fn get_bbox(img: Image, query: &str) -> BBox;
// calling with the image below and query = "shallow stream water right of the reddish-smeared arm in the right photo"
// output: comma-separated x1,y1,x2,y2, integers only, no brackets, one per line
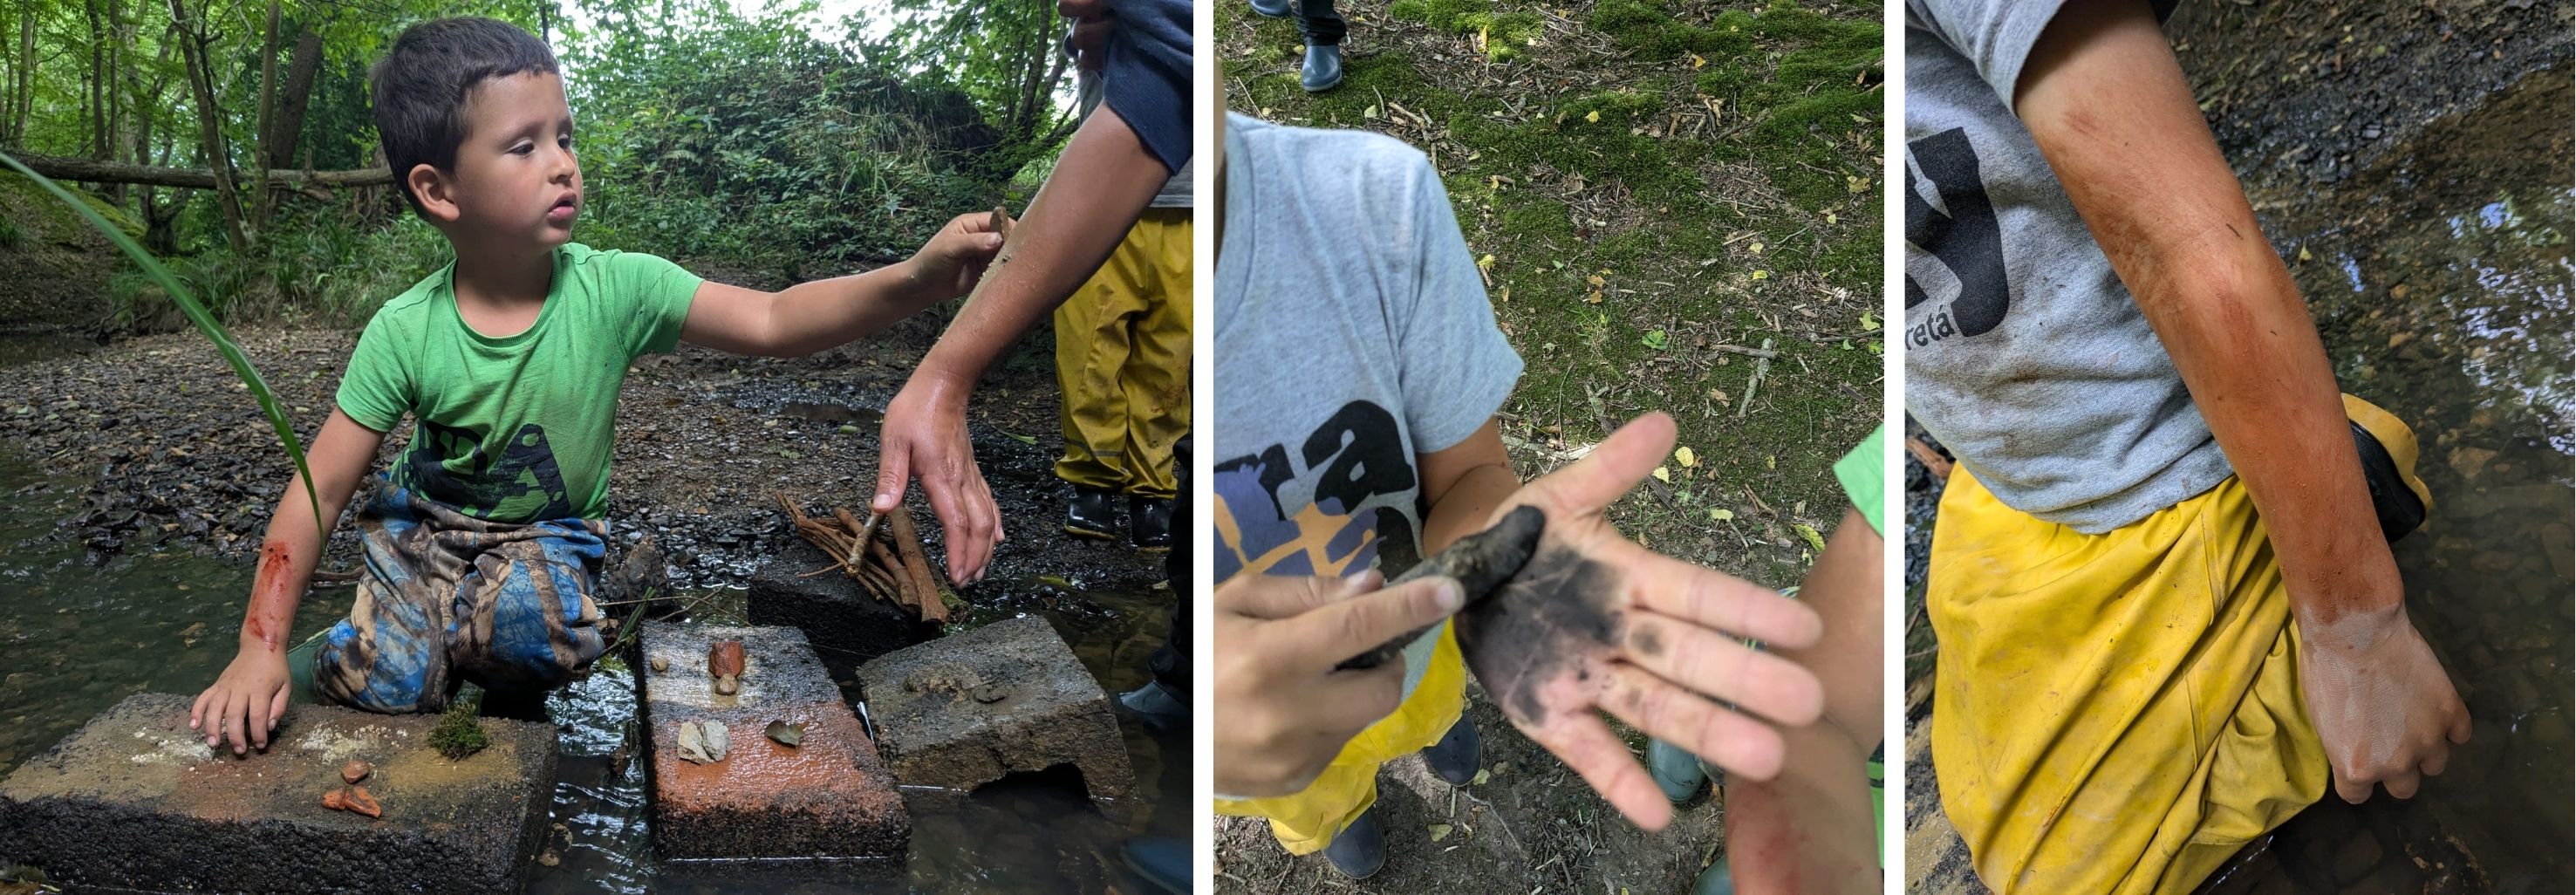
2233,67,2576,892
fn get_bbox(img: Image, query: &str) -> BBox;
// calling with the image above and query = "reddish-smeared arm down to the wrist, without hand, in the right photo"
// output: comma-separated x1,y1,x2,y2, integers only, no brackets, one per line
2017,3,2401,625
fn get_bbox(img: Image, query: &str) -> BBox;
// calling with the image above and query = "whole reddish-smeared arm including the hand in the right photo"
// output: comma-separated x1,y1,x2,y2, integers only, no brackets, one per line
2017,0,2468,803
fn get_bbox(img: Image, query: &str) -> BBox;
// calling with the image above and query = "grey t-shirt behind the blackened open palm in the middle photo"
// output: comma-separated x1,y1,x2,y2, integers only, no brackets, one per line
1211,113,1520,691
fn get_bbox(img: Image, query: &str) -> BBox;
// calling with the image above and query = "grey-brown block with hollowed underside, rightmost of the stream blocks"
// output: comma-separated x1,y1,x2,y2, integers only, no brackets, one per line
858,617,1136,817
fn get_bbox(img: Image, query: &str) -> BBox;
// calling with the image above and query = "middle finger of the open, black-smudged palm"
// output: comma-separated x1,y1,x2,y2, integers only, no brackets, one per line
1625,611,1824,725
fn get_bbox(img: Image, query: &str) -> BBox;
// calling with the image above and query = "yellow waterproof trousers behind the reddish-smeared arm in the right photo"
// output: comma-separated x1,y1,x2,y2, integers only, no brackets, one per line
1924,397,2429,895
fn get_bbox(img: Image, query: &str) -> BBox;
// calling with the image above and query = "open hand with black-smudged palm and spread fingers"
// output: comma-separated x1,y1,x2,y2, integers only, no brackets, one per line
1455,413,1824,830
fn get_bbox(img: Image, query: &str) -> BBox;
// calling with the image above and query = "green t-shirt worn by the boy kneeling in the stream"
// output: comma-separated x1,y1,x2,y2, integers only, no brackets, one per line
338,243,700,523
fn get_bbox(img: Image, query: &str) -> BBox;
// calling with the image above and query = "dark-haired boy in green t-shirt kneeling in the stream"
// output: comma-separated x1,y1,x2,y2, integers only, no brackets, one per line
188,18,1002,753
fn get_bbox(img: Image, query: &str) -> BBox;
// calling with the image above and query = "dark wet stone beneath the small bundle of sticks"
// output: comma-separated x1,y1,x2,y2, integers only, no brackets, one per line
744,539,940,671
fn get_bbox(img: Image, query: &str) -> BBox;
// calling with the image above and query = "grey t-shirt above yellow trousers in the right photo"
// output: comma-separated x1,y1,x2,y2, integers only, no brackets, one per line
1903,0,2231,534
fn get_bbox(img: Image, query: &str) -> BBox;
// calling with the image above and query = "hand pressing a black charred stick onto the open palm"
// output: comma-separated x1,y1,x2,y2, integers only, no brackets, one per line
1213,570,1463,797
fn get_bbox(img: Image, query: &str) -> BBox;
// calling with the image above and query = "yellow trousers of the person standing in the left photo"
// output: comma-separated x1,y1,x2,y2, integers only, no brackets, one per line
1056,208,1190,498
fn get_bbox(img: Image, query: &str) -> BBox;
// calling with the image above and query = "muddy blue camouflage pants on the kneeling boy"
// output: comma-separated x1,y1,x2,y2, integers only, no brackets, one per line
314,485,608,712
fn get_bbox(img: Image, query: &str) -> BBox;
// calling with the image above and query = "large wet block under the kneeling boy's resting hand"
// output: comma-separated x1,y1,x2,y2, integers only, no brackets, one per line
0,693,554,892
